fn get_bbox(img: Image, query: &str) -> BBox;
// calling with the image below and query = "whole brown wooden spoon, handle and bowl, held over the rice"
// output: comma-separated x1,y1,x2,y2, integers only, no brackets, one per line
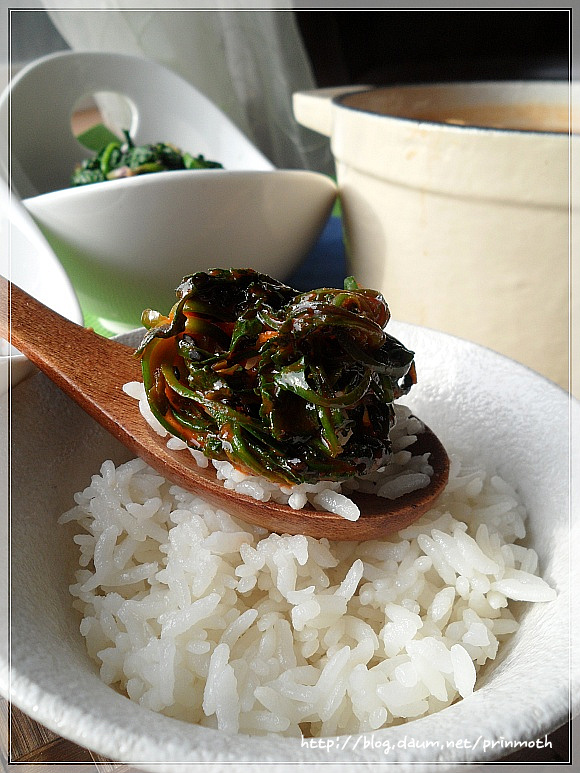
0,278,449,541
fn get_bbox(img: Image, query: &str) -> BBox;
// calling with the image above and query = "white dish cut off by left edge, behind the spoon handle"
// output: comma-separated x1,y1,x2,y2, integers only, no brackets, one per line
0,180,83,392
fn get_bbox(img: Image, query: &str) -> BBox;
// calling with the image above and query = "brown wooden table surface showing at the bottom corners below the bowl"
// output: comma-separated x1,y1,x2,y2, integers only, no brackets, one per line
0,698,571,773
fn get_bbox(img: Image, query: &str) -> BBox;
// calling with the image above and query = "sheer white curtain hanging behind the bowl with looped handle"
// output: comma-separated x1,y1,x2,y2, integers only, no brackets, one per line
43,0,333,173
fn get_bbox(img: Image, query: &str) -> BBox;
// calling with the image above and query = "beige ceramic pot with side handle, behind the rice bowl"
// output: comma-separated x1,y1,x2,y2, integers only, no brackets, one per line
294,82,578,387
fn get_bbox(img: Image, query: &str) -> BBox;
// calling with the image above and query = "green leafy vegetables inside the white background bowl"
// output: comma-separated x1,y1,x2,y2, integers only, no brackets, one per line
71,131,223,187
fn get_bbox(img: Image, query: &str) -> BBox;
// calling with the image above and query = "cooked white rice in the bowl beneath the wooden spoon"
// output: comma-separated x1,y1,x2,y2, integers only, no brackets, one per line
60,446,555,736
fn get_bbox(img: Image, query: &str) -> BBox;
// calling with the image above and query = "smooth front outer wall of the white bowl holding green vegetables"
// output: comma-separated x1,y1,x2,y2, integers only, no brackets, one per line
24,170,336,333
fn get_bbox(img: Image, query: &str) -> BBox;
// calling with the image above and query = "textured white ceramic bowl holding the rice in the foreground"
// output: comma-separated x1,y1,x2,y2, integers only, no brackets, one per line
0,322,580,773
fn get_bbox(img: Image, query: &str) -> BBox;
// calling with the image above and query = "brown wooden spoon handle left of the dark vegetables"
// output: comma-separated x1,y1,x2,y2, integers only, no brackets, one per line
0,277,141,435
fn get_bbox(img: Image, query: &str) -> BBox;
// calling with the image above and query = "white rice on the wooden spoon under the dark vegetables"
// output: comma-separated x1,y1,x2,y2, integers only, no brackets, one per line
123,381,433,521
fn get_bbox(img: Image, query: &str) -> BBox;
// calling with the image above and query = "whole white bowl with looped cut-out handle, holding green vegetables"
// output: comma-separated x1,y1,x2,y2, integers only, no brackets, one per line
0,52,336,333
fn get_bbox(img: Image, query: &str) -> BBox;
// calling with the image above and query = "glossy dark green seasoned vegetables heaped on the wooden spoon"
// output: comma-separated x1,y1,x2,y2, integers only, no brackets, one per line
137,269,416,483
